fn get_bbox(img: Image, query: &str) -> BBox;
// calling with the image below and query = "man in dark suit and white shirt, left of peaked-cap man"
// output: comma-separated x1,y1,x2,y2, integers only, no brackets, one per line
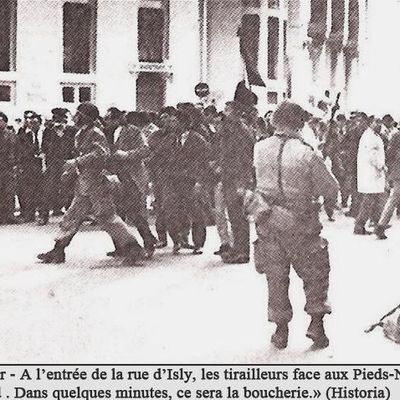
16,111,43,222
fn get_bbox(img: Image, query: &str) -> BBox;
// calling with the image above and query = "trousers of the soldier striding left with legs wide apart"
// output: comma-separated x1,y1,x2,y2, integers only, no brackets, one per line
56,191,137,248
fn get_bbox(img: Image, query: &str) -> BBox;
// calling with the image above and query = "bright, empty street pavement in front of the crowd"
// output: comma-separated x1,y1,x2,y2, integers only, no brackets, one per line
0,214,400,363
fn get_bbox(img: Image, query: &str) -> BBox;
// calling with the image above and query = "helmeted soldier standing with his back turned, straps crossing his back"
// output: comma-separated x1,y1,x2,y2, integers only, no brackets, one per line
248,102,338,349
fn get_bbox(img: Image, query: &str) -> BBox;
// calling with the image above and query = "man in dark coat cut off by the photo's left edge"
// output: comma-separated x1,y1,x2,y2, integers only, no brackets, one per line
0,112,15,224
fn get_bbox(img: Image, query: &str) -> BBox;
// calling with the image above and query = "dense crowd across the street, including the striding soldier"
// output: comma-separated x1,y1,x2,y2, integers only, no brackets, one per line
0,92,400,264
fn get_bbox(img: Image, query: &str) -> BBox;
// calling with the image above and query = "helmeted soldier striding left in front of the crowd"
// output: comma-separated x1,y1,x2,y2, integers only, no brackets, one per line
38,102,141,263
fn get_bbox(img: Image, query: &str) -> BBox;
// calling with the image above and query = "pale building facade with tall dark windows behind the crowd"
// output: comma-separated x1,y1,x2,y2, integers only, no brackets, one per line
0,0,394,115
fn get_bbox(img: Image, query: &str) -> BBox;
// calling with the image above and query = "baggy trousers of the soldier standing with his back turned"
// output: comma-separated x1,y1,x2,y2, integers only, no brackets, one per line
254,233,331,324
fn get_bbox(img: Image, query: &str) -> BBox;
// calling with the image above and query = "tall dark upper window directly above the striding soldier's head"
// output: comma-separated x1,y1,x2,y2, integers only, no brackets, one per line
63,1,96,74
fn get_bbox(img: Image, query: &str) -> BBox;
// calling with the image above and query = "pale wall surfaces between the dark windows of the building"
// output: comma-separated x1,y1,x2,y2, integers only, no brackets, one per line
0,0,390,119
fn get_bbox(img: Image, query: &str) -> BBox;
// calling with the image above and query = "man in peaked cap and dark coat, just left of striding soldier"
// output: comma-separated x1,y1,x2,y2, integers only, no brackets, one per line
39,108,76,225
